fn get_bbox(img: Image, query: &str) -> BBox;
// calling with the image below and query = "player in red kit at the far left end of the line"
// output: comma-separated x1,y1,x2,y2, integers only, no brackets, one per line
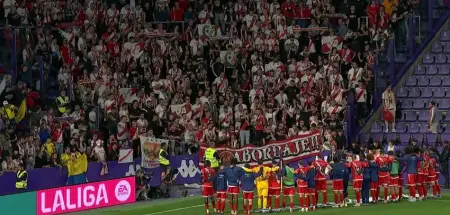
202,160,216,214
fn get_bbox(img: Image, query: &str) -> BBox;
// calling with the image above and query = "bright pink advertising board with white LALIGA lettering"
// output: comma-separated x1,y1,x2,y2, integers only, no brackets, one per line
36,177,136,215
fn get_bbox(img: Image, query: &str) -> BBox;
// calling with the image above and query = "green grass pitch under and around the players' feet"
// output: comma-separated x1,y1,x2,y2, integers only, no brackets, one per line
76,190,450,215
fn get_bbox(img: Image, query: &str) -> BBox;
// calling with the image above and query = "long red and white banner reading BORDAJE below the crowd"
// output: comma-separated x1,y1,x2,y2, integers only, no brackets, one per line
199,130,323,167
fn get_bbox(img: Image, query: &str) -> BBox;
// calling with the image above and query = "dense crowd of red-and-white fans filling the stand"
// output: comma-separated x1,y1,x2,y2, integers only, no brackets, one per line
0,0,417,171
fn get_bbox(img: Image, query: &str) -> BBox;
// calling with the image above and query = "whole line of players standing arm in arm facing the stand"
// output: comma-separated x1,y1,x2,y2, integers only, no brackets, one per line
202,146,441,215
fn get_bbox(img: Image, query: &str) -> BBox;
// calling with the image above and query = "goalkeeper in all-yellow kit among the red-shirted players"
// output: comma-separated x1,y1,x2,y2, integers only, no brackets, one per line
253,160,278,213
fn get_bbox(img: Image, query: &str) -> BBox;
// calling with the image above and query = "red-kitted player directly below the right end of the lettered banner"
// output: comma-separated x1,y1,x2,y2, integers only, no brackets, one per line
313,153,331,205
